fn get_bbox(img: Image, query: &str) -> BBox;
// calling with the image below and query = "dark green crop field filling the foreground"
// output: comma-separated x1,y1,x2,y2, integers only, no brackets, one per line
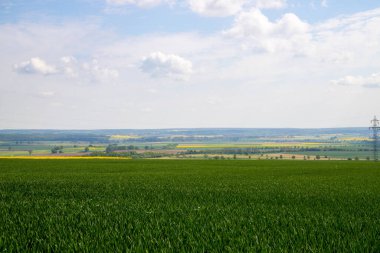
0,159,380,252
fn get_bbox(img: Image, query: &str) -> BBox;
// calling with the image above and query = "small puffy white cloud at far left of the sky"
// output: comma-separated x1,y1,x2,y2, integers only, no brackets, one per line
14,57,57,75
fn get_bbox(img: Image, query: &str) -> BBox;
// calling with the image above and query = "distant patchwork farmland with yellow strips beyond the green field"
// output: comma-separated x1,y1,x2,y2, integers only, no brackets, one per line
0,128,373,160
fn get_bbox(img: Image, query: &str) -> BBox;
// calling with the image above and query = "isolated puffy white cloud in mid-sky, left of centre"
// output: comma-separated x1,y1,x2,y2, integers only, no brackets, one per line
141,52,193,80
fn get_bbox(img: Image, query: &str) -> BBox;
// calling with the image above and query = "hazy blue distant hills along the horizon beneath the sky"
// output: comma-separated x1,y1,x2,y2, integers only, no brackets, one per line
0,127,370,142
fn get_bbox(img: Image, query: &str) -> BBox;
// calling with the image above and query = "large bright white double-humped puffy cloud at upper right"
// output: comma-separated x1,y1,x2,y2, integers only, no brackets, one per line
224,8,310,53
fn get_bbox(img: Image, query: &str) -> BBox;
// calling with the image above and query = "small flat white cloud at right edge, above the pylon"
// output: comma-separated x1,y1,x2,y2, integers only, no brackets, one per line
331,73,380,88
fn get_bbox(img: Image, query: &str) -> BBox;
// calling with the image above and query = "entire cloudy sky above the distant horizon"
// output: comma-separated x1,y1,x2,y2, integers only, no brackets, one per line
0,0,380,129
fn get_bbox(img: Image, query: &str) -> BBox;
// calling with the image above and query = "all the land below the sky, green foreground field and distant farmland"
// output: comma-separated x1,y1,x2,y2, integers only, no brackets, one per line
0,128,380,252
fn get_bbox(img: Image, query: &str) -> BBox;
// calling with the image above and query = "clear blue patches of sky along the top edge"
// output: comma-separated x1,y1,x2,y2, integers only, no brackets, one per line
0,0,380,32
